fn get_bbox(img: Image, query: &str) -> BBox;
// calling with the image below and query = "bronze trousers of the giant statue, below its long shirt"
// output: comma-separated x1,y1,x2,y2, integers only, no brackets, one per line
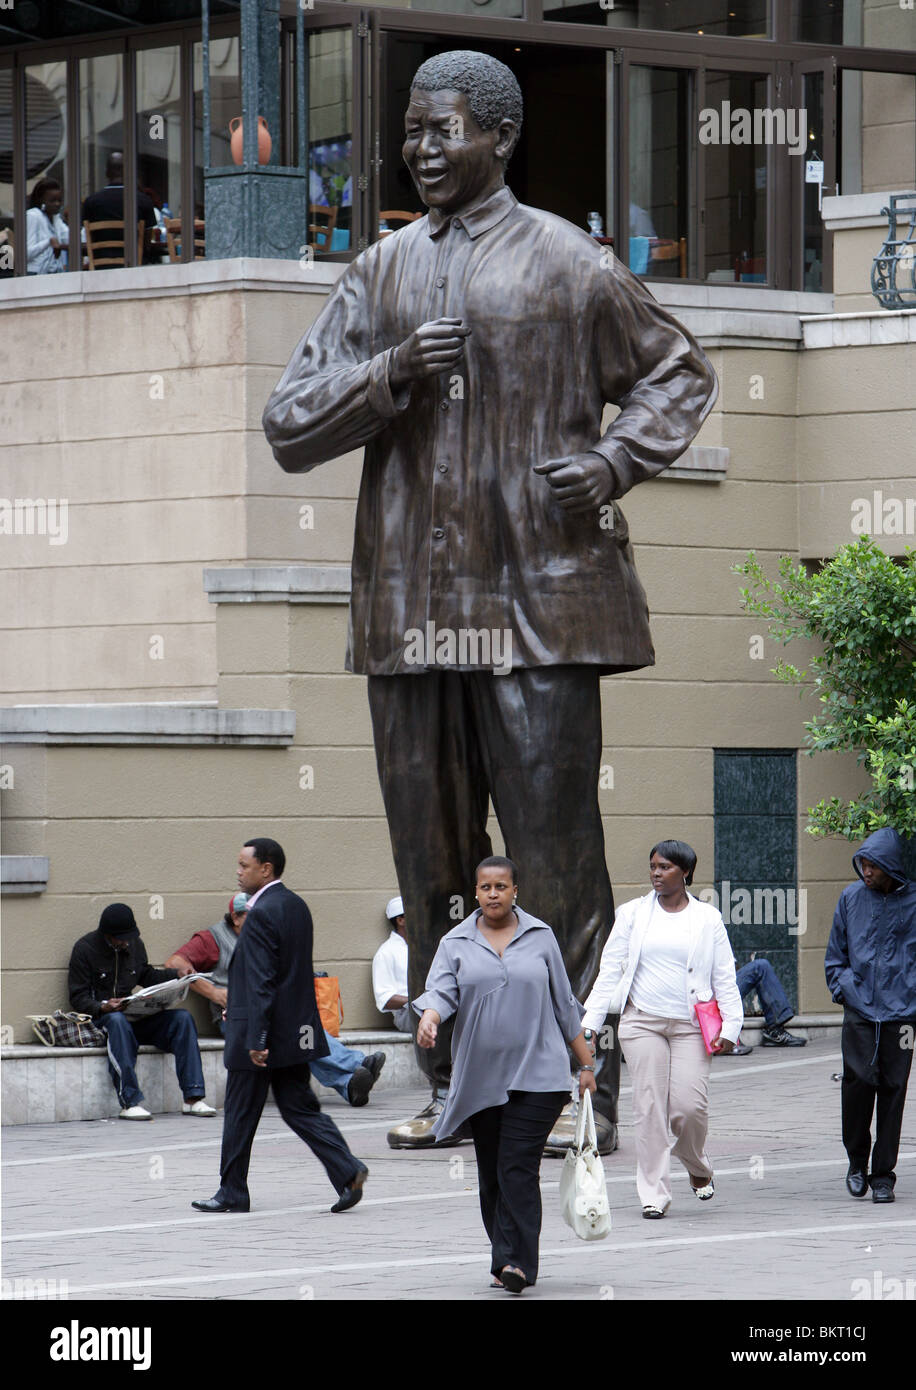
368,666,620,1123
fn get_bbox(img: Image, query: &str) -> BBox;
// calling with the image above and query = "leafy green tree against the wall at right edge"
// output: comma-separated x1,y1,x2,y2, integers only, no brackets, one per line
734,537,916,841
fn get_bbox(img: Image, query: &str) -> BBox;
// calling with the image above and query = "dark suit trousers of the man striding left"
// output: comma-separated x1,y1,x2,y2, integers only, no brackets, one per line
217,1062,359,1207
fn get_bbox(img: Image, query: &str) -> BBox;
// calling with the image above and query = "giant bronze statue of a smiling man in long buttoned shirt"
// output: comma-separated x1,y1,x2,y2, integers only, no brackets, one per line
264,51,717,1152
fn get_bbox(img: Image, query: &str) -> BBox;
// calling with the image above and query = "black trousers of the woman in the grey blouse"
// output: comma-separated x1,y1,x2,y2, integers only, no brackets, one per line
468,1091,570,1284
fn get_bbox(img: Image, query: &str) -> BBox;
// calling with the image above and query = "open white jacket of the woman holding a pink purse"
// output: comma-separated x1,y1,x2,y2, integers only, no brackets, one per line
582,891,744,1043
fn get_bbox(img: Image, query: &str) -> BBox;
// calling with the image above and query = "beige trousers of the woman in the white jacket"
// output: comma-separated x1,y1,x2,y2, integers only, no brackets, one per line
617,1004,713,1211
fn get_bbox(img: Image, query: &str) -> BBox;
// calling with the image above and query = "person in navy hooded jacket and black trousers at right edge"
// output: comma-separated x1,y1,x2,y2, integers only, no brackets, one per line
824,828,916,1202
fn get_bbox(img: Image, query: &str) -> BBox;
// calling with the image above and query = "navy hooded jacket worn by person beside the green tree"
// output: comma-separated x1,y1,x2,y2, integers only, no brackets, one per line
824,828,916,1023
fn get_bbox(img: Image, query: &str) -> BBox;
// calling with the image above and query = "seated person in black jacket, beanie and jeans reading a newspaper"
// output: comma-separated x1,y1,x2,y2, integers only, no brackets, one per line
68,902,217,1120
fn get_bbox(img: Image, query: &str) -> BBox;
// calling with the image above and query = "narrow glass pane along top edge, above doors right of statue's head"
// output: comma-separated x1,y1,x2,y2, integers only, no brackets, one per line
547,0,770,39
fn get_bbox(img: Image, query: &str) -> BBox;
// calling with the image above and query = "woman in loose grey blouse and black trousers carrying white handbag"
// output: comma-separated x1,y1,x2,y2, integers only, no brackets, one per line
413,858,595,1293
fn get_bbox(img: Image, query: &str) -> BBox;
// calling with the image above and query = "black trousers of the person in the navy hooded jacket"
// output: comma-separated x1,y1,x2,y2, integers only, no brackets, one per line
841,1008,916,1184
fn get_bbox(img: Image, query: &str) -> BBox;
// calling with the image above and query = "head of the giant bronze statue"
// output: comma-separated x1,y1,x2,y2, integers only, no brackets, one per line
403,49,521,213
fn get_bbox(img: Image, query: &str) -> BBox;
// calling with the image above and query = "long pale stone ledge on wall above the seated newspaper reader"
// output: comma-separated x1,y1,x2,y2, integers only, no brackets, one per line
0,702,296,748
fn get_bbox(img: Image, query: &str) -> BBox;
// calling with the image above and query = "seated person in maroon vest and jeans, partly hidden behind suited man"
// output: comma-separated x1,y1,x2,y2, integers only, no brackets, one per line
165,892,385,1106
